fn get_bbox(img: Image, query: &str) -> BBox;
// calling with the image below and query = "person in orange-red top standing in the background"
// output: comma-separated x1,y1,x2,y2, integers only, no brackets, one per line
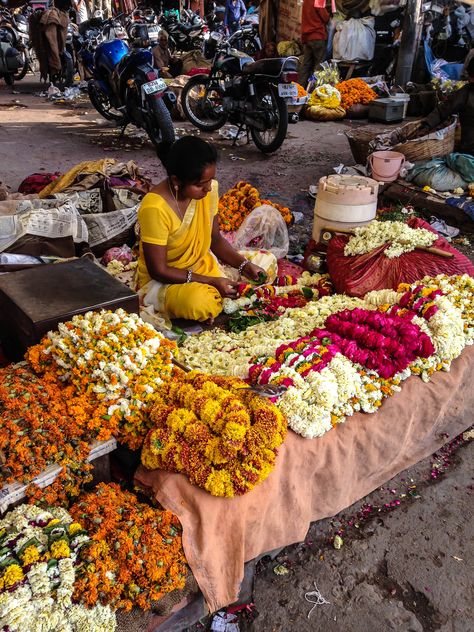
299,0,331,88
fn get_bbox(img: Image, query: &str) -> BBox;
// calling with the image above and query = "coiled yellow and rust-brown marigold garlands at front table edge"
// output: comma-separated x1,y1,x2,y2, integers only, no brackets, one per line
142,372,286,497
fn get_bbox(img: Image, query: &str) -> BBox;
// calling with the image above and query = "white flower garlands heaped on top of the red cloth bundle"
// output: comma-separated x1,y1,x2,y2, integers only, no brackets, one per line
344,220,437,259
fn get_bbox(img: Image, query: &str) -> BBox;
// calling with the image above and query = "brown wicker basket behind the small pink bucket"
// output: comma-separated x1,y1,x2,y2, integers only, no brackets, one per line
392,119,456,162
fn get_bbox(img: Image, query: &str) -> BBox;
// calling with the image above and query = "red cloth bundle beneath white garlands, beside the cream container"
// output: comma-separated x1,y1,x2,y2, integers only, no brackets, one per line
327,217,474,297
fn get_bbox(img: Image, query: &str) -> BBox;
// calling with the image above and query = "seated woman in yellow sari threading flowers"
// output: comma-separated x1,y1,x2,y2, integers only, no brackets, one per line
137,136,266,321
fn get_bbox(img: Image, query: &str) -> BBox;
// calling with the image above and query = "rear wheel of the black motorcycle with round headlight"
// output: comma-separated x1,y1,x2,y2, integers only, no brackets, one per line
249,84,288,154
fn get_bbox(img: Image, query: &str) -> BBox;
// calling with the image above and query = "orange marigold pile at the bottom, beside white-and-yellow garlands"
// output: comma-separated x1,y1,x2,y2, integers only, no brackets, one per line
70,483,188,610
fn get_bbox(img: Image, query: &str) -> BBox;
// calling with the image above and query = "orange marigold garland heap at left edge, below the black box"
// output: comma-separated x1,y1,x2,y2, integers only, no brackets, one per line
0,363,117,502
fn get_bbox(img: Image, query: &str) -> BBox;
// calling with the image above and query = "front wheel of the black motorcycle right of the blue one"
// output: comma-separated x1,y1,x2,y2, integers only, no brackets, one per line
181,75,227,132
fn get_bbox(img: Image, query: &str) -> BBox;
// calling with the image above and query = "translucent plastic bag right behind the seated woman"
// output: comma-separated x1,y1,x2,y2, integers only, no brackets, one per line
234,204,290,259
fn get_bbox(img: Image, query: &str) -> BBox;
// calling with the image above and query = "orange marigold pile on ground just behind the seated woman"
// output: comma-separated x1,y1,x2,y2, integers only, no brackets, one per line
218,181,293,232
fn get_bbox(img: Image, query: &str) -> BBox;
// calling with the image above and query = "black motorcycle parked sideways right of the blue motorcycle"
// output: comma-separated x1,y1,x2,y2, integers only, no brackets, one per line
181,31,298,153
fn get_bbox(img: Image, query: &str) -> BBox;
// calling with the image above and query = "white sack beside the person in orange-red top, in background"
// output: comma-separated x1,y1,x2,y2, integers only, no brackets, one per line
333,17,375,61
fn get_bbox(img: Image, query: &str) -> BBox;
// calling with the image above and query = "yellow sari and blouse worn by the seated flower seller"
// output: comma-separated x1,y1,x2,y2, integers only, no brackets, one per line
137,180,222,321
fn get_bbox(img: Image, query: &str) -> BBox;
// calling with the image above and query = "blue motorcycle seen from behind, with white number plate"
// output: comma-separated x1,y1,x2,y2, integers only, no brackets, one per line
88,39,176,150
